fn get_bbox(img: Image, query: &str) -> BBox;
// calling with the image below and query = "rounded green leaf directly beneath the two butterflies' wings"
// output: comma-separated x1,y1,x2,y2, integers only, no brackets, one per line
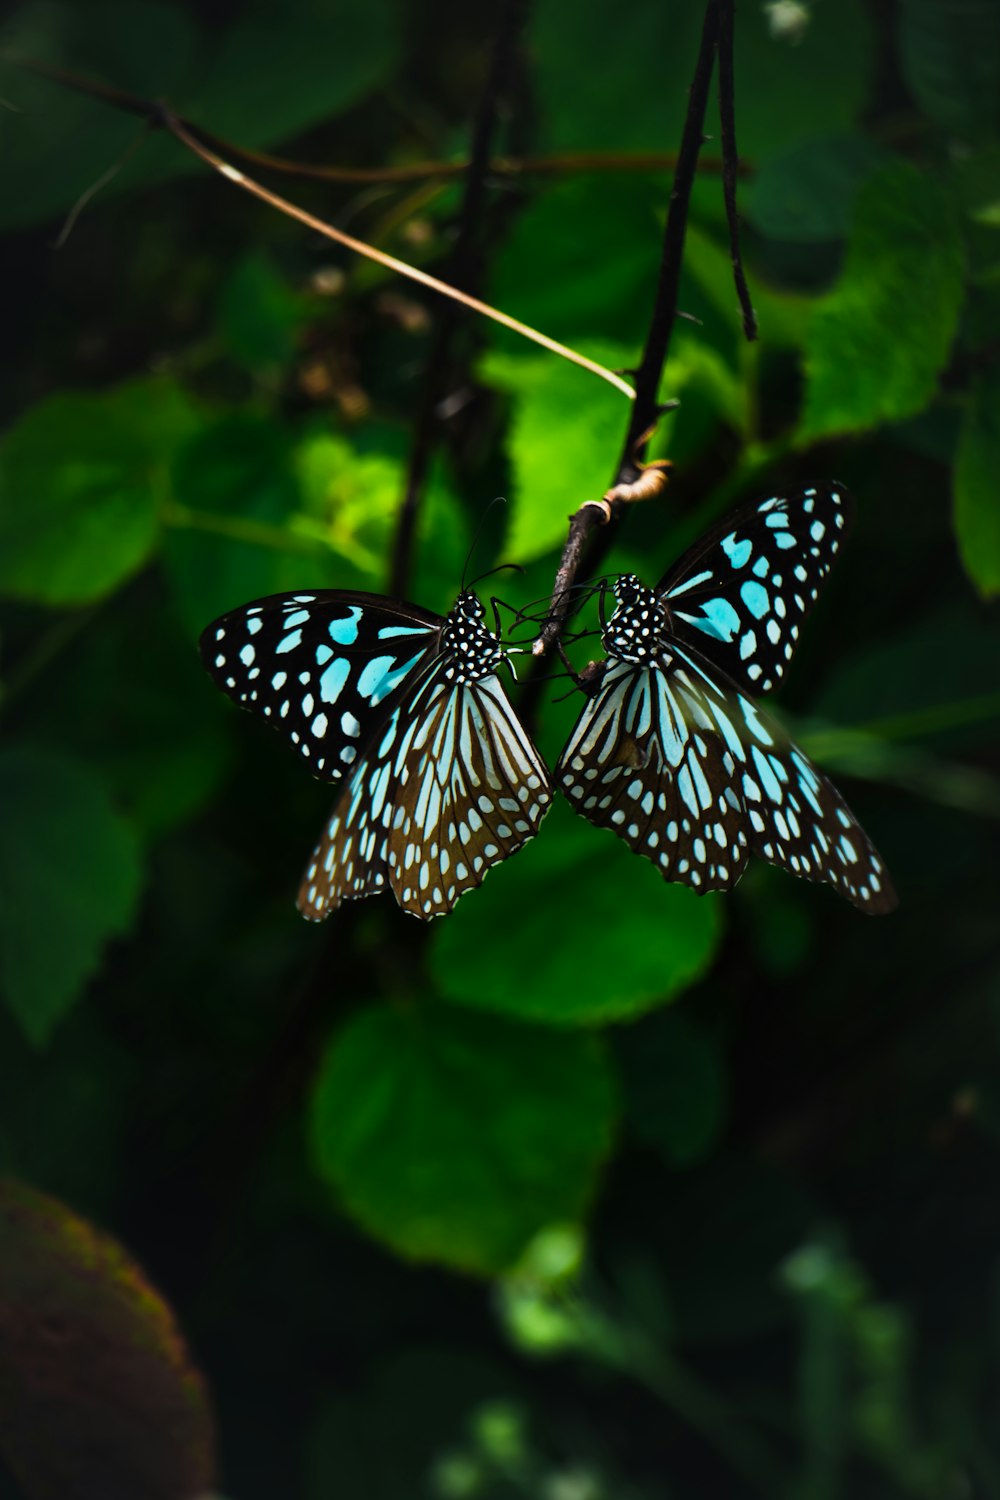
430,801,723,1026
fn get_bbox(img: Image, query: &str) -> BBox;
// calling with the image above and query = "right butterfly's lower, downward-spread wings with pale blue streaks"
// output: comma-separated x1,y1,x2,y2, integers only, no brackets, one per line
556,648,897,915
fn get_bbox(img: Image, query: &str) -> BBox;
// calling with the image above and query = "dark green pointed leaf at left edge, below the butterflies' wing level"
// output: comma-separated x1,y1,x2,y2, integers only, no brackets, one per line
0,749,139,1047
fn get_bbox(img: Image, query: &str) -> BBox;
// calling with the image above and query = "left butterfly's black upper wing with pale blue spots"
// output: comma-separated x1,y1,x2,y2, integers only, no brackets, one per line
199,590,442,782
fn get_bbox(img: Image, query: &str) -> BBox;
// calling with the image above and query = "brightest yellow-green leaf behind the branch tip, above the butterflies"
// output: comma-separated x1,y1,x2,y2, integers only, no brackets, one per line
480,341,630,563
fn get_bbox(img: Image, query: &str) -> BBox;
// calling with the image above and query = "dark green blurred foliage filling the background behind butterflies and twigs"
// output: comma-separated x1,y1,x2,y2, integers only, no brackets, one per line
0,0,1000,1500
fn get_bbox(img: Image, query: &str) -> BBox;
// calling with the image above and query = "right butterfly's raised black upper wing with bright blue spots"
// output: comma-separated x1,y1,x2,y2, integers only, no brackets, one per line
657,485,853,693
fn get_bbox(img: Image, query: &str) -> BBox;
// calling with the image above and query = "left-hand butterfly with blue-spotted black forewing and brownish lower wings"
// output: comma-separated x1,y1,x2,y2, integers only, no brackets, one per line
199,590,552,921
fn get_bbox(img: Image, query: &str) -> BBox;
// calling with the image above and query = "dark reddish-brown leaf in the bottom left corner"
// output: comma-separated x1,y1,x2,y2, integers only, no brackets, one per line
0,1179,214,1500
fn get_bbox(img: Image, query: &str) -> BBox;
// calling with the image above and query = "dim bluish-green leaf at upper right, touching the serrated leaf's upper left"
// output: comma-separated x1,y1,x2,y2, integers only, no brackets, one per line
742,135,891,245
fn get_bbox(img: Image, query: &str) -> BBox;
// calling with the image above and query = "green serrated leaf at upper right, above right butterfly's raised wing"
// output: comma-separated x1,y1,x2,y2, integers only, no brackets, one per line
799,164,963,444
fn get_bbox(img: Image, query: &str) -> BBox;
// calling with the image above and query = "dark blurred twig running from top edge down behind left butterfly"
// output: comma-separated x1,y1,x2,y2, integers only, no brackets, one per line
390,0,526,599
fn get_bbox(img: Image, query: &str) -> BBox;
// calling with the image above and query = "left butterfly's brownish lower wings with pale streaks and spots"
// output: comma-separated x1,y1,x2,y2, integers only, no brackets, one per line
298,669,552,921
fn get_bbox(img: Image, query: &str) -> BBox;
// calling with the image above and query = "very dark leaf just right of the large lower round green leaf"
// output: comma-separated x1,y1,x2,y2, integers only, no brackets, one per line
616,1010,727,1167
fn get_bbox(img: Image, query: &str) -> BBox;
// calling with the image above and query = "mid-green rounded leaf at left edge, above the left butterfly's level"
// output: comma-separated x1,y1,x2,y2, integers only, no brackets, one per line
0,380,198,605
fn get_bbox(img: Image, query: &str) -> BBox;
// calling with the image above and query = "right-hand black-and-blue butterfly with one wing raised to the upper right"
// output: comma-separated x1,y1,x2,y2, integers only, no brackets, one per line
555,485,897,914
